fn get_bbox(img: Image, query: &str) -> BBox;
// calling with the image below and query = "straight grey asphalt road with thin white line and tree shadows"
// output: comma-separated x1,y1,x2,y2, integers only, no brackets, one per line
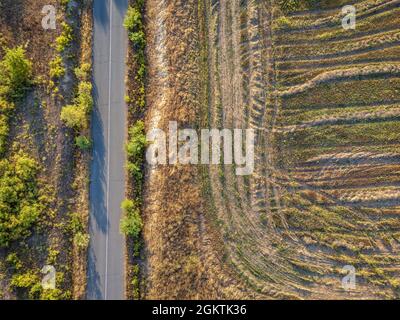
87,0,128,300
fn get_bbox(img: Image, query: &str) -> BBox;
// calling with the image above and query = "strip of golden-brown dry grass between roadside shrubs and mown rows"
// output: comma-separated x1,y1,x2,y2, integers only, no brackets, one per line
143,0,253,299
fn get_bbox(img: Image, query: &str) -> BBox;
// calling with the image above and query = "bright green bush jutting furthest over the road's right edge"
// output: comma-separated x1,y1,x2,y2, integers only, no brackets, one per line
121,200,143,238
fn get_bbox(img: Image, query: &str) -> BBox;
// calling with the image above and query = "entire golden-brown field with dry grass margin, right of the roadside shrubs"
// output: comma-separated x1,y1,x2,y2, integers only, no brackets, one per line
144,0,400,299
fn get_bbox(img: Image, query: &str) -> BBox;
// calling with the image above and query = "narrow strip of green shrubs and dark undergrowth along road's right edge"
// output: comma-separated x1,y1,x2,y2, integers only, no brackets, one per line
121,0,146,299
